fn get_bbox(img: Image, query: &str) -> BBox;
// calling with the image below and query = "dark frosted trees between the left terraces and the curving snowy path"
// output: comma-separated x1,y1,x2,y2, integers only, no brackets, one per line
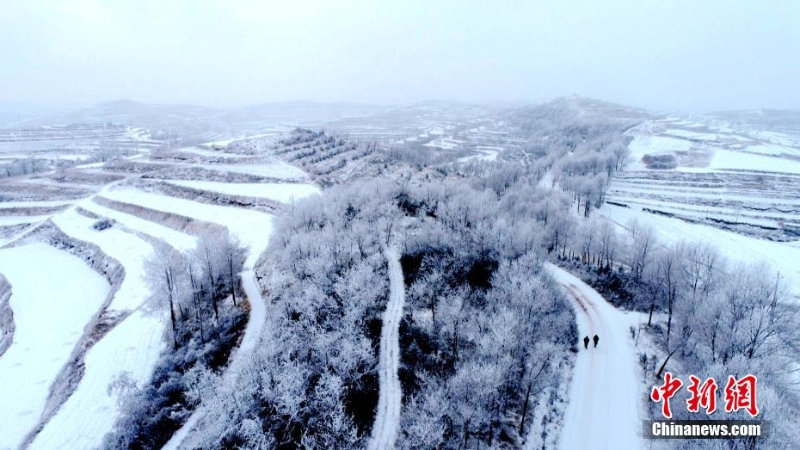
104,233,247,448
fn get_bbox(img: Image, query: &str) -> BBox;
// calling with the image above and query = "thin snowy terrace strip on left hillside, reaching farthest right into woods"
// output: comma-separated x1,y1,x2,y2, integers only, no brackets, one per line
166,180,320,203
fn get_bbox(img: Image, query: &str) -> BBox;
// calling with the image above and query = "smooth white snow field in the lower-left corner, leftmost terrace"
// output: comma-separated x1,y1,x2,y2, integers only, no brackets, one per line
0,243,110,449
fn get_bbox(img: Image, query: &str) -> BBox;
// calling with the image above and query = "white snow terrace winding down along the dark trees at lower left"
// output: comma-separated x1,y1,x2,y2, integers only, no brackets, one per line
29,211,164,449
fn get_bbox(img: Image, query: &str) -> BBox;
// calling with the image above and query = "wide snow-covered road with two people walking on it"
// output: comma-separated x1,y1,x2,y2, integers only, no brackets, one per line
547,264,643,450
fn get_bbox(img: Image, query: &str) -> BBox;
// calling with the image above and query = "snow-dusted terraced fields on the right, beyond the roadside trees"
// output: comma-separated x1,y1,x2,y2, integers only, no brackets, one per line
600,117,800,294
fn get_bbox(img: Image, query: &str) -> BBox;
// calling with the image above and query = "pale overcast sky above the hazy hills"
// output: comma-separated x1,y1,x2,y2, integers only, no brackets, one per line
0,0,800,112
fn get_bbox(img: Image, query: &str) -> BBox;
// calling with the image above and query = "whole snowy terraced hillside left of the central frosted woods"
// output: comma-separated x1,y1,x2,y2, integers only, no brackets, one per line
0,133,324,448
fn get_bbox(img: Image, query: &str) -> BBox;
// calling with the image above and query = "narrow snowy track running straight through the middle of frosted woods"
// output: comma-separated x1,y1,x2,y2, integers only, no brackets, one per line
369,247,406,450
